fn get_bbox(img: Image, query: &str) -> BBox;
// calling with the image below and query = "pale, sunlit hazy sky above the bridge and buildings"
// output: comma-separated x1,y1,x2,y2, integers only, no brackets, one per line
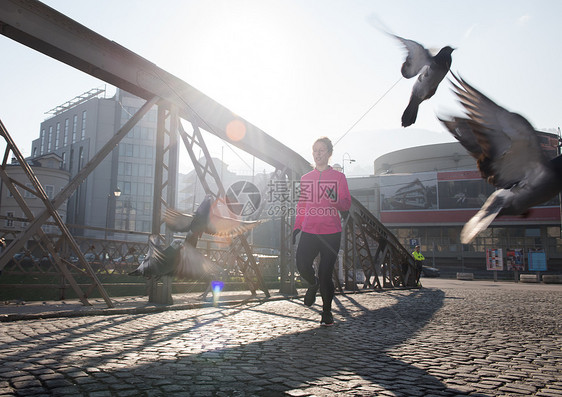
0,0,562,176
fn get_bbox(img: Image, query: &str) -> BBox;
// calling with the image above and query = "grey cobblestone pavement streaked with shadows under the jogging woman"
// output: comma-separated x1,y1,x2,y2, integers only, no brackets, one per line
0,280,562,397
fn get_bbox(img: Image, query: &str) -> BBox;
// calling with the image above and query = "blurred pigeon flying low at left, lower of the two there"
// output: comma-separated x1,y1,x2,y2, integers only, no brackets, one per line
129,234,223,298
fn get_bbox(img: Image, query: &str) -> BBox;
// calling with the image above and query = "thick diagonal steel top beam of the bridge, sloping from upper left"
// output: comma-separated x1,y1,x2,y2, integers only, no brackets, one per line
0,0,311,175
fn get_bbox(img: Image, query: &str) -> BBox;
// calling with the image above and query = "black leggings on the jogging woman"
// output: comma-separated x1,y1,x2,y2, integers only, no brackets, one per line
297,232,341,311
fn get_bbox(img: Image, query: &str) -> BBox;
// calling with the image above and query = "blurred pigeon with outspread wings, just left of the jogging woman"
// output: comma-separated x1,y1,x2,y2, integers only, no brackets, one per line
164,195,263,247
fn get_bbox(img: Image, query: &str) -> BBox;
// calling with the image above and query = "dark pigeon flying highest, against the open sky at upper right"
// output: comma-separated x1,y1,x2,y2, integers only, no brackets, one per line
388,33,454,127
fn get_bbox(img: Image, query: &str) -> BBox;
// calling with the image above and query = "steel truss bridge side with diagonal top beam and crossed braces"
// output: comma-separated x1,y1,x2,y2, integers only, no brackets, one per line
0,0,415,307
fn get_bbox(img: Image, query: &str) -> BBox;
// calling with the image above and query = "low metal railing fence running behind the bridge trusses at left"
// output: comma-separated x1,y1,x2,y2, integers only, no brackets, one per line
0,223,279,300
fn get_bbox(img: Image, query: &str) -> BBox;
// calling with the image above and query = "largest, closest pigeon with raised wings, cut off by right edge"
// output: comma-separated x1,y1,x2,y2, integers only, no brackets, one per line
440,75,562,244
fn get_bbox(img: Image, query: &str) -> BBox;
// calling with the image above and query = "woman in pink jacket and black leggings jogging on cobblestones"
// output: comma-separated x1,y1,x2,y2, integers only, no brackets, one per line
293,137,351,325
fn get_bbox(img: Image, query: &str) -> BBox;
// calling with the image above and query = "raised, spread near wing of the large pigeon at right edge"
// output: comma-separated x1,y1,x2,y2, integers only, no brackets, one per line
453,76,546,188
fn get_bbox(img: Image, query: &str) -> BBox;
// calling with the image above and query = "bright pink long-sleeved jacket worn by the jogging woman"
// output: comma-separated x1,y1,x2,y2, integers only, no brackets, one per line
294,167,351,234
